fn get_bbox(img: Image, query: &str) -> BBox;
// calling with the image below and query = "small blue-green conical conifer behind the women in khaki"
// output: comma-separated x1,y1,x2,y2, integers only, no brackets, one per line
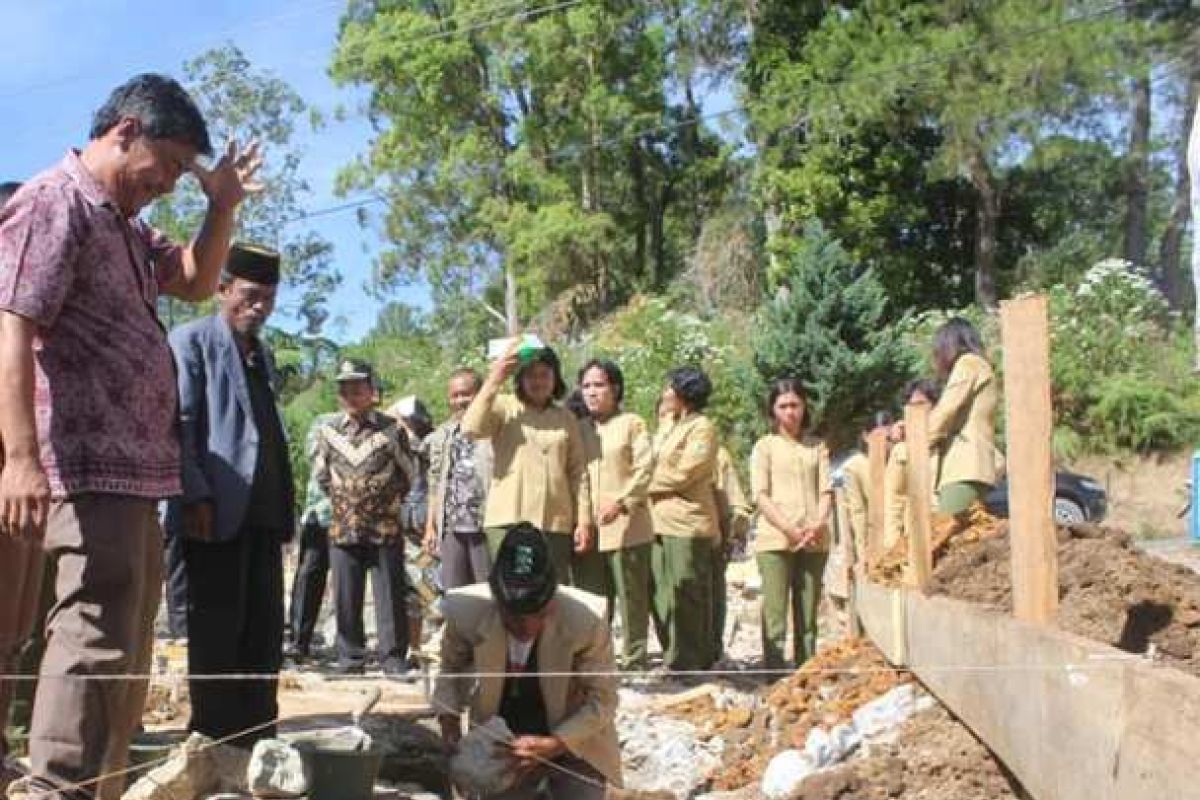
754,223,916,447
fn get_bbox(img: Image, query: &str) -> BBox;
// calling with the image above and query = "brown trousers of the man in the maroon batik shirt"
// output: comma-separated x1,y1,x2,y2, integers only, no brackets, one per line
30,494,162,800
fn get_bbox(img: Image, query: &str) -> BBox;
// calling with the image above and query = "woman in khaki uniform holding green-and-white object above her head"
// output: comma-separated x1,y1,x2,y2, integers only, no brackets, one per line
462,338,594,584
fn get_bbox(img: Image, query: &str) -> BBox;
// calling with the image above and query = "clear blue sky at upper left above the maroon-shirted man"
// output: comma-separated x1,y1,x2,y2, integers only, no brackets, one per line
0,0,428,341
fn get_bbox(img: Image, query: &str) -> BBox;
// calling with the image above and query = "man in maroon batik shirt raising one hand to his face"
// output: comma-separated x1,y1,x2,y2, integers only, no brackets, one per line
0,74,260,800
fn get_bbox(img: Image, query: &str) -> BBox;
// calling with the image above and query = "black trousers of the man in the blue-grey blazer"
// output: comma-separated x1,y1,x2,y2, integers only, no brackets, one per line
184,527,283,747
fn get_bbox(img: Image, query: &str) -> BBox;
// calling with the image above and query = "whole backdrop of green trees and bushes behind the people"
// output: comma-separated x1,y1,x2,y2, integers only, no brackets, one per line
147,0,1200,494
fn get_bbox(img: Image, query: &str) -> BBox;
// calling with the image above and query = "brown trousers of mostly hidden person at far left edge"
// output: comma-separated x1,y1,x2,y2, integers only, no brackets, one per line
0,534,42,758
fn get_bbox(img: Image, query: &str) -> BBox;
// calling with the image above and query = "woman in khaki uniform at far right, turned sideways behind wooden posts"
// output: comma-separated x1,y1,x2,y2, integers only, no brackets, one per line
929,317,1000,515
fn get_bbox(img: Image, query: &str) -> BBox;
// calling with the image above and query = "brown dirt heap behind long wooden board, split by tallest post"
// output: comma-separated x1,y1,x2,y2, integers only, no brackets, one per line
930,525,1200,675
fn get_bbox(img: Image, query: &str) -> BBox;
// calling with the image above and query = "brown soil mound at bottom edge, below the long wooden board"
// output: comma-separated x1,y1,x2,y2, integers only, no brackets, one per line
796,706,1024,800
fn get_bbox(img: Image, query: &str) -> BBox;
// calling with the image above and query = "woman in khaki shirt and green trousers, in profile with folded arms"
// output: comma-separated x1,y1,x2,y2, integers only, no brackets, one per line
648,367,719,670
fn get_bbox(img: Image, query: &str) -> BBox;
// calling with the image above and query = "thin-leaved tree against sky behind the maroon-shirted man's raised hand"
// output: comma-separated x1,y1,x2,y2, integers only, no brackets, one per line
150,44,341,336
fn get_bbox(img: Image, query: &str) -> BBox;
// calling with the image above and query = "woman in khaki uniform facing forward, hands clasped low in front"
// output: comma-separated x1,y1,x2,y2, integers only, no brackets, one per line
750,378,833,669
